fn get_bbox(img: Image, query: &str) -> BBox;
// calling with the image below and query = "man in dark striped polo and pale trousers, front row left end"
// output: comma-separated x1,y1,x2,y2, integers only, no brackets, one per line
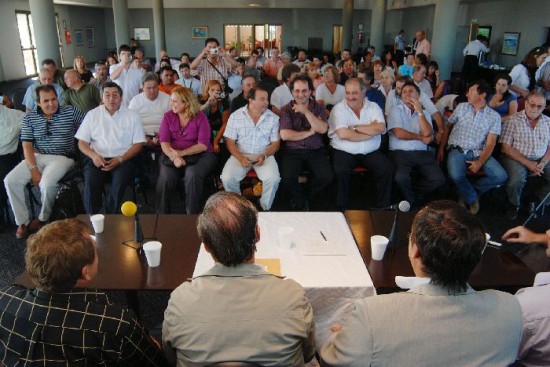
4,84,84,238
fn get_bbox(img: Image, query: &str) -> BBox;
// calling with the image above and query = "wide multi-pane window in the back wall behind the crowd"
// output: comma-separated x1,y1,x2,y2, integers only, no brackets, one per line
224,24,283,57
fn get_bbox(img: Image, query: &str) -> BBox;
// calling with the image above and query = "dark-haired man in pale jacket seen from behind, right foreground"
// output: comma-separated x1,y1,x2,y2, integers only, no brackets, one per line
320,201,521,367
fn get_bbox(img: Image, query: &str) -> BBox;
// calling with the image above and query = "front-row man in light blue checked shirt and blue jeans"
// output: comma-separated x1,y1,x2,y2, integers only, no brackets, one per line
442,80,507,214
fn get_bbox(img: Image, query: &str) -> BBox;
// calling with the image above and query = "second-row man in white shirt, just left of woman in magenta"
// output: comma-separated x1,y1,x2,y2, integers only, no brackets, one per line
128,73,170,147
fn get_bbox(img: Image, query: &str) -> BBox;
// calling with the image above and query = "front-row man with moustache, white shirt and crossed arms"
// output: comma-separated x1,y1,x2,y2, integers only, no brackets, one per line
328,78,394,210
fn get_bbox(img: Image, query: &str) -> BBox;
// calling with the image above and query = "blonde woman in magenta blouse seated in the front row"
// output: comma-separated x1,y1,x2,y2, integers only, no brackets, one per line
156,86,217,214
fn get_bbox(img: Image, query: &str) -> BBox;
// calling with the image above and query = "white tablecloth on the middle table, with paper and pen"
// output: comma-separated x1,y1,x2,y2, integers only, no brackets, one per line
193,212,376,345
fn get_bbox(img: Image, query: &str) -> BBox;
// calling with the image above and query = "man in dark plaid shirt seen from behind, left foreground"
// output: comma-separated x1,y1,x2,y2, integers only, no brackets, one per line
0,219,165,366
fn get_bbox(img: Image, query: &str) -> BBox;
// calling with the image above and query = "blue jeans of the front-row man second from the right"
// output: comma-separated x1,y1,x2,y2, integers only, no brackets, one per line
447,149,507,205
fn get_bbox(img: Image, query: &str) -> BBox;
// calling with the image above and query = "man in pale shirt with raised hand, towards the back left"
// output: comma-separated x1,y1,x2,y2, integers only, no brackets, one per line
109,45,145,107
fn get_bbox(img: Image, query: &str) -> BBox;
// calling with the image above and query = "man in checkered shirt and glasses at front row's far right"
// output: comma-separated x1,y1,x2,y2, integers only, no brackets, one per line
500,92,550,220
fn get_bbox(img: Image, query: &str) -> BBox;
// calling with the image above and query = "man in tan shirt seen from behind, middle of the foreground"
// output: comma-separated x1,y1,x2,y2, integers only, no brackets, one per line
162,191,315,367
